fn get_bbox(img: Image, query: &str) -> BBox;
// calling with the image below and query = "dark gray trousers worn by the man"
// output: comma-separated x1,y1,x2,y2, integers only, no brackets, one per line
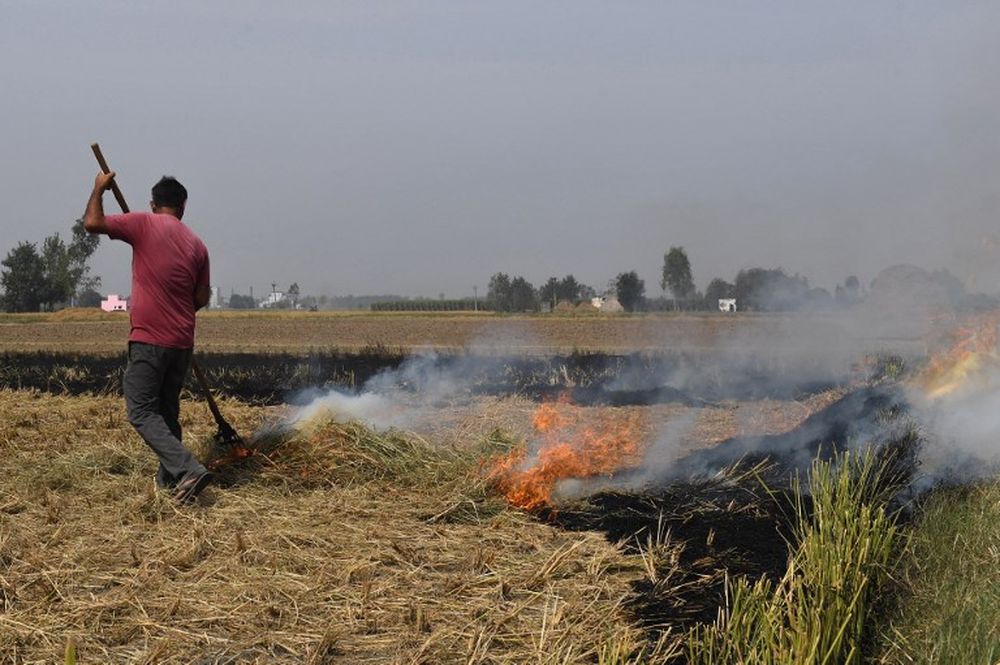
123,342,205,487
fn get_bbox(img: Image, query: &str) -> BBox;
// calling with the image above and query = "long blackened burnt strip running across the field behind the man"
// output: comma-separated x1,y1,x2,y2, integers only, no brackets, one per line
0,347,845,406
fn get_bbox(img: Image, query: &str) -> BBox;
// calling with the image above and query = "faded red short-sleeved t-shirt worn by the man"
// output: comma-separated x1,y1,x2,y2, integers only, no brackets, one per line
104,212,209,349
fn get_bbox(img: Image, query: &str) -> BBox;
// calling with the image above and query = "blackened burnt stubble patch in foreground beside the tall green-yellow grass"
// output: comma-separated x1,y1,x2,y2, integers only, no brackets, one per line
543,384,920,640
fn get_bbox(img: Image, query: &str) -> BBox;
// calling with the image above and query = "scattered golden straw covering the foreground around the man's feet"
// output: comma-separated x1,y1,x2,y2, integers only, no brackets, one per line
0,390,676,663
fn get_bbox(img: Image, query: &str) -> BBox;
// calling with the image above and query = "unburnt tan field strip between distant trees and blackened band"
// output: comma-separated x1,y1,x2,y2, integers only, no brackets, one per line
0,309,832,353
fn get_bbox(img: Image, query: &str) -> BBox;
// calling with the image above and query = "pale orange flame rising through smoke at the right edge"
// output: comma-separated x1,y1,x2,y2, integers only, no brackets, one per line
916,312,1000,399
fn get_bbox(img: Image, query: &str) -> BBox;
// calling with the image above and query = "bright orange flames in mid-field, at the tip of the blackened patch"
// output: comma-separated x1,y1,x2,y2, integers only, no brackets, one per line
487,397,645,511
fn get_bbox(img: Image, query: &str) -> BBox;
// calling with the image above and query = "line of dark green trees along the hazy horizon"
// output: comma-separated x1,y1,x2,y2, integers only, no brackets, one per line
0,232,964,312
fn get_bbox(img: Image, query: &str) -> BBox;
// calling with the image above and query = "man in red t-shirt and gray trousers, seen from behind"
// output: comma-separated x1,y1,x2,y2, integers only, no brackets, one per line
83,172,212,502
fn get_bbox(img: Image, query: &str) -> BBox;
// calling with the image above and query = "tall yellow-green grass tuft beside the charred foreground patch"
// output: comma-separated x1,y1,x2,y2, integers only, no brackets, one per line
688,453,899,665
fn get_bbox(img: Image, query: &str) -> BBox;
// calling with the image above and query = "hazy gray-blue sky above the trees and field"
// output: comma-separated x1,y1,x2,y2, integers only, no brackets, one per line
0,0,1000,296
